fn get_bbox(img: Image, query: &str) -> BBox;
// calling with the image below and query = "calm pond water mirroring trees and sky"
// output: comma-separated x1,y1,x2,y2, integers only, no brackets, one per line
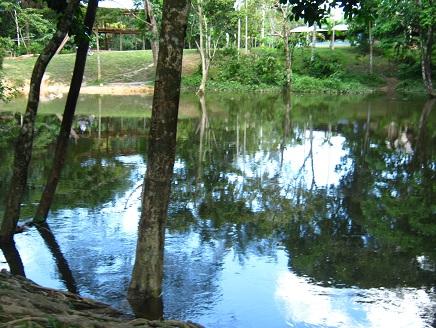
0,94,436,327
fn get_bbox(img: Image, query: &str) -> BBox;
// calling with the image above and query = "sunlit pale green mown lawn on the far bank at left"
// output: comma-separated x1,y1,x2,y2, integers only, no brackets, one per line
4,50,199,85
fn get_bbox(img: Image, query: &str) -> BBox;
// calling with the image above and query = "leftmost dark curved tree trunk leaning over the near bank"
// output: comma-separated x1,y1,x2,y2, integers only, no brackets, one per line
0,0,79,243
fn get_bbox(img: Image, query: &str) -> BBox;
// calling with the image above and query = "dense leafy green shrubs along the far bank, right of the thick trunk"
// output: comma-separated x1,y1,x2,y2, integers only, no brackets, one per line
183,48,424,94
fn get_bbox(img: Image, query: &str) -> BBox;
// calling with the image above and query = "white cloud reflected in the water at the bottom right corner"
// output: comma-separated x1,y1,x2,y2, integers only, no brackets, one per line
275,272,435,328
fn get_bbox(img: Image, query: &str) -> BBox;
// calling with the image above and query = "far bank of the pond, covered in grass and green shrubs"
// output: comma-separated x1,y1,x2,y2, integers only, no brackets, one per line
4,47,424,96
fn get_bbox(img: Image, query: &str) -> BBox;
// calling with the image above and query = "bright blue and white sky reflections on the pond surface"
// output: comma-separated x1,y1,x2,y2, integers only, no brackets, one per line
0,93,436,328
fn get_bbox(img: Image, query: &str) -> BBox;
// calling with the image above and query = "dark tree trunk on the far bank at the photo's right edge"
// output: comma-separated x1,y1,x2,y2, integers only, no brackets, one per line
421,26,436,98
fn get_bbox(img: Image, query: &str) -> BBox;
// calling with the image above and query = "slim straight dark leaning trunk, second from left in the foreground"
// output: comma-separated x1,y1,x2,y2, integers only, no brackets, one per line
33,0,98,223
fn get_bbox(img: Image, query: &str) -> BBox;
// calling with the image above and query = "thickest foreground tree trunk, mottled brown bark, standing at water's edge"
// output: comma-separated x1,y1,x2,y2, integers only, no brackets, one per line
128,0,190,318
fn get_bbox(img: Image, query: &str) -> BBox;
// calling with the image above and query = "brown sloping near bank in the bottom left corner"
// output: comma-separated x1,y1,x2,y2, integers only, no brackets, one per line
0,270,201,328
